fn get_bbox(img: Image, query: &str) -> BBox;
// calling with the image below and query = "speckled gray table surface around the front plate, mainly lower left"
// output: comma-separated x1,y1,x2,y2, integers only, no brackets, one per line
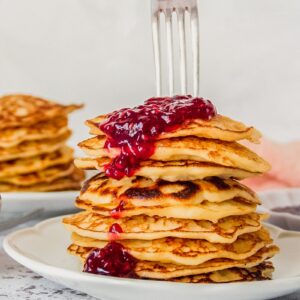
0,220,300,300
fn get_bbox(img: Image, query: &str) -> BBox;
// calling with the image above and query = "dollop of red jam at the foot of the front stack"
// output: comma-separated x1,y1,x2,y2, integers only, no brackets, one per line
83,242,137,278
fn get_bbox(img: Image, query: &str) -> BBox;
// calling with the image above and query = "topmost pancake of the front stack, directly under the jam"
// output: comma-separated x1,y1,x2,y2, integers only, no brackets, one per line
86,115,261,143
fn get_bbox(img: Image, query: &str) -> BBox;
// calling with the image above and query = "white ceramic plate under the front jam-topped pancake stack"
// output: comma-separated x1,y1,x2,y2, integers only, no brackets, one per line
3,217,300,300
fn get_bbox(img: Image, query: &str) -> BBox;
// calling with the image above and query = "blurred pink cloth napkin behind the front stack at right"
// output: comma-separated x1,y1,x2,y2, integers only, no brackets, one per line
243,138,300,191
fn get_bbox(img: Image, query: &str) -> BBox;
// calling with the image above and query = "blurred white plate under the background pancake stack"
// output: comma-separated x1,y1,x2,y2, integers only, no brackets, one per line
1,191,79,214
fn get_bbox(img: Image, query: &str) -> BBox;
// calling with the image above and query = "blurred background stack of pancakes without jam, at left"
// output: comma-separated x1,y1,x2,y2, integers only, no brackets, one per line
0,95,83,192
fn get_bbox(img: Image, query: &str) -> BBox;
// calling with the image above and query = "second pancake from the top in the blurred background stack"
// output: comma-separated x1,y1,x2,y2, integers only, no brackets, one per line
0,117,69,148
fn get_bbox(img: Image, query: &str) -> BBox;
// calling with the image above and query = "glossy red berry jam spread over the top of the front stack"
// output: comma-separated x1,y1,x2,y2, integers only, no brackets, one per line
99,95,217,179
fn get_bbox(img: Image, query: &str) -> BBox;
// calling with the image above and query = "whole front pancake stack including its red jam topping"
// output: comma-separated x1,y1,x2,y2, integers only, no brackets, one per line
62,96,279,283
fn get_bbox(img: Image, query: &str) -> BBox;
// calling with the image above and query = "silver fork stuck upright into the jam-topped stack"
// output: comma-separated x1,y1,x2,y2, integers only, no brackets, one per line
151,0,200,96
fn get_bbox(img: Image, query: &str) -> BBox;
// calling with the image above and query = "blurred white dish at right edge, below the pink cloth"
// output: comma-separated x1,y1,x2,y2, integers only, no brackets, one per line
259,188,300,231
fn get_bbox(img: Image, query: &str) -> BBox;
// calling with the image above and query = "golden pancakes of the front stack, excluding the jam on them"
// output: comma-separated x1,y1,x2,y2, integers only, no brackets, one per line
63,111,278,283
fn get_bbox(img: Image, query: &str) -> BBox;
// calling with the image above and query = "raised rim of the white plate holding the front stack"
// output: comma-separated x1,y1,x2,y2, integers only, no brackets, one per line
3,215,300,290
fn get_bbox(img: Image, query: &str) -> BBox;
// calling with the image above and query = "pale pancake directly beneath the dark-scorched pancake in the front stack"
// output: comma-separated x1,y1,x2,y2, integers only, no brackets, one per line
75,198,256,223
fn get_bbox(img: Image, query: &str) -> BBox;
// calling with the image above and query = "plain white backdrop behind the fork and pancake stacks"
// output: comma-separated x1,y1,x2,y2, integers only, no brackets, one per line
0,0,300,149
